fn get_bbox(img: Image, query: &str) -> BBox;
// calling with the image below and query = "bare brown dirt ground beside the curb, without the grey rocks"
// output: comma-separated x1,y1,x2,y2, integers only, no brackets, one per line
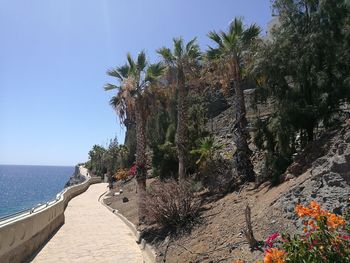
104,171,310,263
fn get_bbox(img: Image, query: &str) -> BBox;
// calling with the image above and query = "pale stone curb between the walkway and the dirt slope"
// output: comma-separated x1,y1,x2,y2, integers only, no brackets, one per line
98,190,157,263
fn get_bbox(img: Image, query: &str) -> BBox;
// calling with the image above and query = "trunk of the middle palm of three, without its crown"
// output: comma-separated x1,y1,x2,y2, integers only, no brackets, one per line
176,67,188,182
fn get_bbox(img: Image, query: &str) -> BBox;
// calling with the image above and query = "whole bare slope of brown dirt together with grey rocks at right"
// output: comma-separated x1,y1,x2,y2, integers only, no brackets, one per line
106,121,350,263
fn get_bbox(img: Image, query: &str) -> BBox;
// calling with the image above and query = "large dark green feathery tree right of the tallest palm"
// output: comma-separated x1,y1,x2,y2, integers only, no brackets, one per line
253,0,350,185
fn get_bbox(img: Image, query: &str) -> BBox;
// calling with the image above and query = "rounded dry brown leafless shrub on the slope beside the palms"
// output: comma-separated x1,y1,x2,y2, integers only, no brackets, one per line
147,180,200,230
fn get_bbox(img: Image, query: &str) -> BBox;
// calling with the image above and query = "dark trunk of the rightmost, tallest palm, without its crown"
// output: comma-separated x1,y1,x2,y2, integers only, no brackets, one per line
233,60,255,183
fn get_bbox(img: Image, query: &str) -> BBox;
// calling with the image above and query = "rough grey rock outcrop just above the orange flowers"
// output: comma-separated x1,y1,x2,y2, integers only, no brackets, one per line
276,123,350,226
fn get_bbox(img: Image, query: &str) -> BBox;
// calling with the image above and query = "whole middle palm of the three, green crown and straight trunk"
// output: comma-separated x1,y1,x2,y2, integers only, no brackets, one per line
157,37,201,182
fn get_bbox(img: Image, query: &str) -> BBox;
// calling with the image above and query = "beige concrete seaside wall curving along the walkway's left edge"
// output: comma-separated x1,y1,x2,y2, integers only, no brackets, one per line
0,177,101,263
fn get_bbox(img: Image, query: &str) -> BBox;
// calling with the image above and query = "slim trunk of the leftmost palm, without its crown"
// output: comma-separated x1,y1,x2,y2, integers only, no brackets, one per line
135,100,147,224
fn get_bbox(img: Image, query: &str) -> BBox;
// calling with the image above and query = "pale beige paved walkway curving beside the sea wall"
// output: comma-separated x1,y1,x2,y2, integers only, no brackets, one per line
33,183,143,263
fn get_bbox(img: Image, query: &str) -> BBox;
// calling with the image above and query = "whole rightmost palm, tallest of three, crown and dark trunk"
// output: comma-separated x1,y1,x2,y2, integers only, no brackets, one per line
207,18,260,182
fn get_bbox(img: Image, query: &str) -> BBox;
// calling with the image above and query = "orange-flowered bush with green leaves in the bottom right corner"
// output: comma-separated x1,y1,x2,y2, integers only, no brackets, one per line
237,201,350,263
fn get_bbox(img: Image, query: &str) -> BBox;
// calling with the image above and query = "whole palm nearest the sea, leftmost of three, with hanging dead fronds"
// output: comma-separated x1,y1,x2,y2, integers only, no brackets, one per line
104,51,164,223
